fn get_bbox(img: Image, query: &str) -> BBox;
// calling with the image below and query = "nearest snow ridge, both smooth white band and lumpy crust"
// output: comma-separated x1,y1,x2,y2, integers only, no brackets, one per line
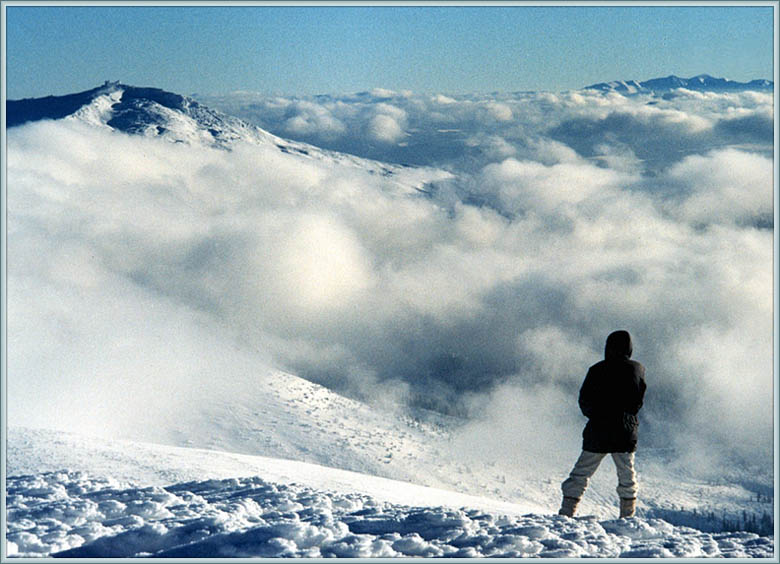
6,430,774,559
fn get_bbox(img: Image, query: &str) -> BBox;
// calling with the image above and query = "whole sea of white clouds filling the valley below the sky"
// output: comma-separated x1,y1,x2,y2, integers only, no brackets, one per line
7,85,774,480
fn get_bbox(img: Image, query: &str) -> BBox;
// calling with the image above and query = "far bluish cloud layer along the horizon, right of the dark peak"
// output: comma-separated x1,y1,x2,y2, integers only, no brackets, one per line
202,88,774,173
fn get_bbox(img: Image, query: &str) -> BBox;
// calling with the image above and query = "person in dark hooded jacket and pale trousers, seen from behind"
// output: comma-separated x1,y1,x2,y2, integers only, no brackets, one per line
558,331,647,518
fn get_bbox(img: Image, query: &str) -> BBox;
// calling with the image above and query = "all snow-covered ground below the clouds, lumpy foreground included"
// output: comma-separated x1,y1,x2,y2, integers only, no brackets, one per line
6,362,773,557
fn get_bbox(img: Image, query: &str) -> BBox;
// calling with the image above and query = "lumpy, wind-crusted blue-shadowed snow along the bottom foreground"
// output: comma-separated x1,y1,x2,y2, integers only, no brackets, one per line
7,471,774,559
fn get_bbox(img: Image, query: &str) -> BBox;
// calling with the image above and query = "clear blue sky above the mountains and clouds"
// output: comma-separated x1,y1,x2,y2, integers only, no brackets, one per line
4,3,773,99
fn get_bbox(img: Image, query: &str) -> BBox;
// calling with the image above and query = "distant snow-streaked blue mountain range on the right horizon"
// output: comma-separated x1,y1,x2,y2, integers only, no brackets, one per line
585,74,775,94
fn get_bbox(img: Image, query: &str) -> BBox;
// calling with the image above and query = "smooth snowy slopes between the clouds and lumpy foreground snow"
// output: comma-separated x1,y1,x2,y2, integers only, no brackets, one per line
7,352,773,555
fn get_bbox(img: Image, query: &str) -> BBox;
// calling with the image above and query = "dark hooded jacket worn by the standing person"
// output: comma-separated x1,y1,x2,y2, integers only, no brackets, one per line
579,331,646,452
